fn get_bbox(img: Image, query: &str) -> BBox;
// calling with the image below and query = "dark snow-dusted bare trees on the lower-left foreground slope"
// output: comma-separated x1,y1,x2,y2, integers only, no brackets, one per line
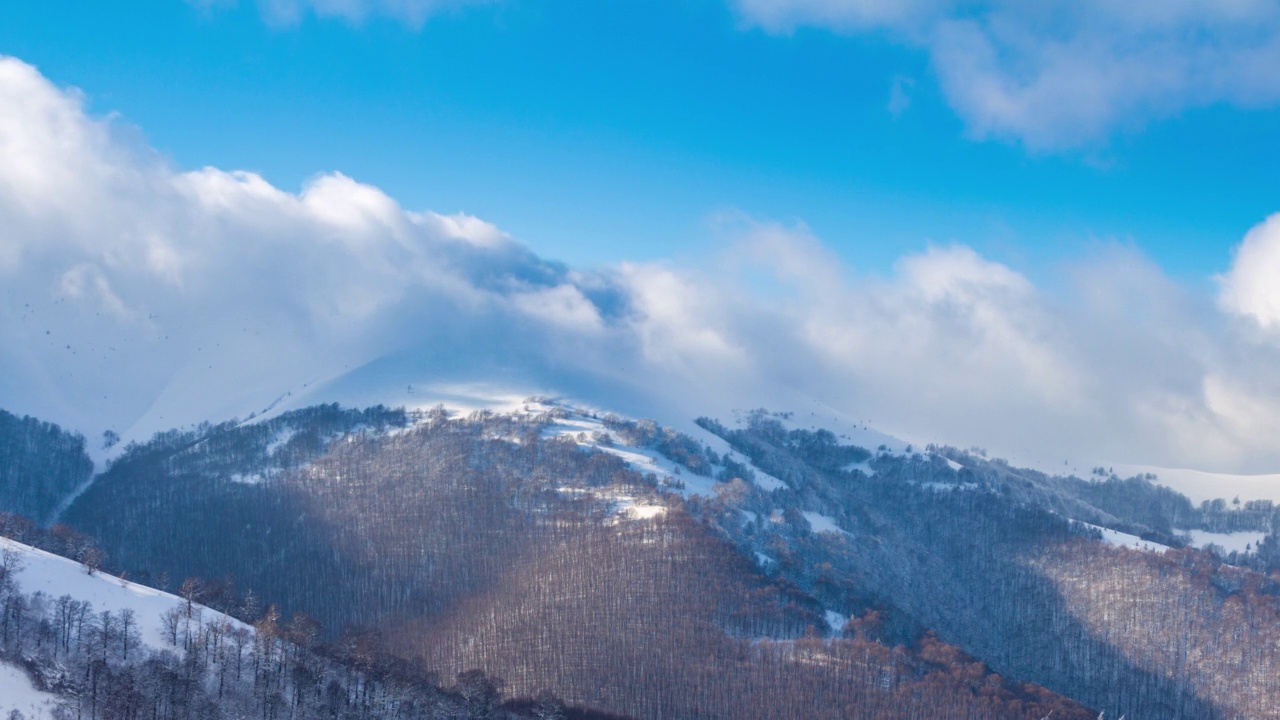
0,565,603,720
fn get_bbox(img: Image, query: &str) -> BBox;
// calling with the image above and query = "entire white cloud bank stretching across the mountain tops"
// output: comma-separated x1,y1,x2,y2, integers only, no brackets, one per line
0,58,1280,471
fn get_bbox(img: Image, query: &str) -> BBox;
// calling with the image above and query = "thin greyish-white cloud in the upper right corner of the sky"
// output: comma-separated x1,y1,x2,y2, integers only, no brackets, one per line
732,0,1280,150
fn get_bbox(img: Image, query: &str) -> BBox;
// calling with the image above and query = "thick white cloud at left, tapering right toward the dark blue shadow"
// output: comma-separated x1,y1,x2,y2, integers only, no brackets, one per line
0,58,591,438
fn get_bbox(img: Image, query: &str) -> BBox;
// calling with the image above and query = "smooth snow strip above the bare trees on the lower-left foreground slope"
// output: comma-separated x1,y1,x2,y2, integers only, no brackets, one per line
0,538,243,648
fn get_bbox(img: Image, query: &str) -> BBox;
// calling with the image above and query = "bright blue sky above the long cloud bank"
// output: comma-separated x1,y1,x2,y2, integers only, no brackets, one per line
0,0,1280,280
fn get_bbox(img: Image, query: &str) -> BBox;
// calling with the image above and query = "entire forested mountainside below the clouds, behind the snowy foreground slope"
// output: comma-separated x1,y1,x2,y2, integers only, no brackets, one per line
0,398,1280,720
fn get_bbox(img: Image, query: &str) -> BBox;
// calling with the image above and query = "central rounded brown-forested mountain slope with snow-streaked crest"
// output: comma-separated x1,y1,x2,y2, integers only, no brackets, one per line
52,404,1091,719
